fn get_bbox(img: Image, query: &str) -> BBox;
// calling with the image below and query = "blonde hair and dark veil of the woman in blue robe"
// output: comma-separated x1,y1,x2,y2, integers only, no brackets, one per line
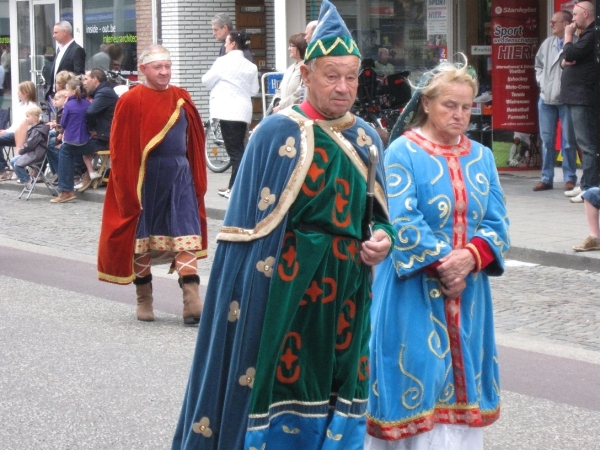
409,61,479,128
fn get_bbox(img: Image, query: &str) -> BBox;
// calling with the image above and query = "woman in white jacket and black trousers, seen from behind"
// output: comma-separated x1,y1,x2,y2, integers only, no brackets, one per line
202,31,258,198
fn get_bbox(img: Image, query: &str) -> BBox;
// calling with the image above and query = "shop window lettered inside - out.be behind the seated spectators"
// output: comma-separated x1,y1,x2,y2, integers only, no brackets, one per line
83,0,137,79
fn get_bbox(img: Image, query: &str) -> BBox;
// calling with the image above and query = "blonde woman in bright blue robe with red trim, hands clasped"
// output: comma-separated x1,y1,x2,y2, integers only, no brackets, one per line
365,63,509,450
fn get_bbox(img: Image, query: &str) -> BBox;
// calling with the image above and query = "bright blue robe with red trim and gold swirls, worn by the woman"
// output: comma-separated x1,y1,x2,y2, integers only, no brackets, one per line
367,131,509,440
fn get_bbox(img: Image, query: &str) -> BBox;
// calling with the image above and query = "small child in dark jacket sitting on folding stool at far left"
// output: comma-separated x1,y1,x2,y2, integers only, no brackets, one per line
10,106,50,191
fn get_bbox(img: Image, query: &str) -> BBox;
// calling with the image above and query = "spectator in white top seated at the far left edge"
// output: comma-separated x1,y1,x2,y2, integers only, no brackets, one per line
0,81,37,181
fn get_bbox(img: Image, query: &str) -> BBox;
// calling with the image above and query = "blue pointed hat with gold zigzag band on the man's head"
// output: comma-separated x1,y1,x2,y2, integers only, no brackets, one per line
304,0,360,61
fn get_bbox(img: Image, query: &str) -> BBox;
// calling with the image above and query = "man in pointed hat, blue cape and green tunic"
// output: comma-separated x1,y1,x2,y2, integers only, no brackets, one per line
172,1,394,450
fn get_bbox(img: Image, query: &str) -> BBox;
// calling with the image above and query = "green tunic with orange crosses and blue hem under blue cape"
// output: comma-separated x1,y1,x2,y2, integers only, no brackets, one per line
246,109,394,450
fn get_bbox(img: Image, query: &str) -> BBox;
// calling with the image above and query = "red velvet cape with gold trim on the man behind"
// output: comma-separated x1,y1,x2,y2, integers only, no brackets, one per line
98,85,208,284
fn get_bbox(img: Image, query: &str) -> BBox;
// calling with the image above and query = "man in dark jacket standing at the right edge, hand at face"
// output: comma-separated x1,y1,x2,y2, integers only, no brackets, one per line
560,1,600,203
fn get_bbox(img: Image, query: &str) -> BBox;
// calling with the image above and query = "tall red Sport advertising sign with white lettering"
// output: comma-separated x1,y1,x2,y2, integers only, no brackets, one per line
492,0,539,133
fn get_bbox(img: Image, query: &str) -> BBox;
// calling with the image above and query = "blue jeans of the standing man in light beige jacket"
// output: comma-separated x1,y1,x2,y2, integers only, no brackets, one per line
538,98,577,185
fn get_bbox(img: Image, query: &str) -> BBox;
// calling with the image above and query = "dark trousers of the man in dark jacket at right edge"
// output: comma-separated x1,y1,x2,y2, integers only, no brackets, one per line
569,105,598,191
